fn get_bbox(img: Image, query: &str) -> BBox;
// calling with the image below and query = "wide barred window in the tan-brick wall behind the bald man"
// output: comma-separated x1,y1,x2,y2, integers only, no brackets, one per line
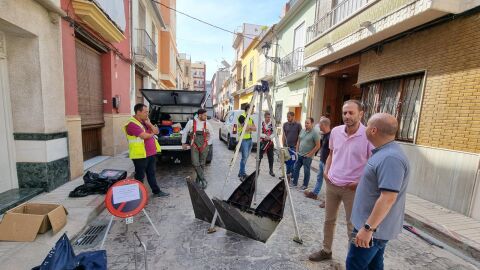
361,73,424,142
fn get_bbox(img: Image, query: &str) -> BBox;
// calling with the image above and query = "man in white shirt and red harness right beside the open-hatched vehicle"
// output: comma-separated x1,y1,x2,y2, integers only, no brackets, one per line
182,109,213,189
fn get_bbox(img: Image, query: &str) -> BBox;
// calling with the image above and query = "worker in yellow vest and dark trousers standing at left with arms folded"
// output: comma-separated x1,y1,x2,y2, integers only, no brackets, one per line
123,103,169,197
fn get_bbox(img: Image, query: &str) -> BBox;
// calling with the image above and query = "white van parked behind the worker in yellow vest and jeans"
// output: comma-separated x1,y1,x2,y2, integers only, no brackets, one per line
218,110,258,150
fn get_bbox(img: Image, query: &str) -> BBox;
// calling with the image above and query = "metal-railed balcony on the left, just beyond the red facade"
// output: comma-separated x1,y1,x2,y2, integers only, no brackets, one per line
135,29,157,71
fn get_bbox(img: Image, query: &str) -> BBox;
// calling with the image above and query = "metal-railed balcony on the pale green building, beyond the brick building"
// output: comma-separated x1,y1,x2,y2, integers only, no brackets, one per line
279,48,310,82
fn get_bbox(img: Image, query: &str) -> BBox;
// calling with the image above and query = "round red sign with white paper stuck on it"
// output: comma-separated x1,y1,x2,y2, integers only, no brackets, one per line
105,179,148,218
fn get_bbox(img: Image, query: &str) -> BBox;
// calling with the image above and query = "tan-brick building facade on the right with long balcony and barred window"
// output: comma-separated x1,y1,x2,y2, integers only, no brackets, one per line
304,0,480,219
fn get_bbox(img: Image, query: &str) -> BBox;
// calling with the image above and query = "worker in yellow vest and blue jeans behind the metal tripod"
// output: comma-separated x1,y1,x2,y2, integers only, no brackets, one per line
237,104,257,181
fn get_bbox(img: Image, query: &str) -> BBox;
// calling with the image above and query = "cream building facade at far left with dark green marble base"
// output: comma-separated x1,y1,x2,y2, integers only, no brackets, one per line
0,1,70,196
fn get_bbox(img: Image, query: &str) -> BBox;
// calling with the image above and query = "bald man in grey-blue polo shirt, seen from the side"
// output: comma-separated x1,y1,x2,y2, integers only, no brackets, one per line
346,113,410,270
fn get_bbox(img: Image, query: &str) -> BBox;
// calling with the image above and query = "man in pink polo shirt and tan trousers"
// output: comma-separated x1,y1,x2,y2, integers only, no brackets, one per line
309,100,374,261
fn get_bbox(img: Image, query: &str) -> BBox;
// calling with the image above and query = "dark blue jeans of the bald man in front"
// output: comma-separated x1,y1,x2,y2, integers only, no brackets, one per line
346,229,388,270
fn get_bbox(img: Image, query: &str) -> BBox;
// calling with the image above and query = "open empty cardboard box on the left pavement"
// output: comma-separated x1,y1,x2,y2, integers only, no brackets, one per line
0,203,68,242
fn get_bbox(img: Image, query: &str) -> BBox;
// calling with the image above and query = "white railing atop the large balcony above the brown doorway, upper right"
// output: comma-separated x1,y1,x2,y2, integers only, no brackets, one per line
307,0,376,42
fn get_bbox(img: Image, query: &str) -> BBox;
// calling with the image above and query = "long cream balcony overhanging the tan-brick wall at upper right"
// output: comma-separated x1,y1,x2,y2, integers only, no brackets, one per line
304,0,478,67
